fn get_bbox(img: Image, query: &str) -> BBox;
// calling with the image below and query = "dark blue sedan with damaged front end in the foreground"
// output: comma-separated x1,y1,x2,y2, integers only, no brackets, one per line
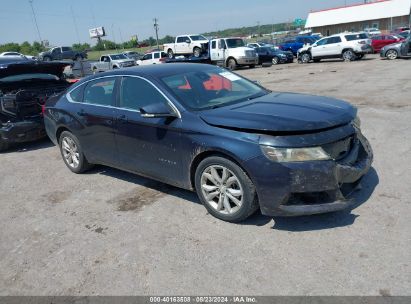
44,64,372,222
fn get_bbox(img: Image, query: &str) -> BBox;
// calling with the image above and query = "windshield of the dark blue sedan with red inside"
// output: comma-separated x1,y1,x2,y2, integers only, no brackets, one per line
161,67,269,111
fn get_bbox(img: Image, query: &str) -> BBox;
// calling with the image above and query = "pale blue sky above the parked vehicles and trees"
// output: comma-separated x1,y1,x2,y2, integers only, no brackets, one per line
0,0,362,45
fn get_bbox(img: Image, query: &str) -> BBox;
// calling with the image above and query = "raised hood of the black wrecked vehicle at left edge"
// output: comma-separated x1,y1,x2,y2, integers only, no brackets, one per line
0,60,70,79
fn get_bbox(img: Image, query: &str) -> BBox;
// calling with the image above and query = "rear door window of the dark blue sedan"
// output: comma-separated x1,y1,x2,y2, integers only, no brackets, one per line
83,77,116,106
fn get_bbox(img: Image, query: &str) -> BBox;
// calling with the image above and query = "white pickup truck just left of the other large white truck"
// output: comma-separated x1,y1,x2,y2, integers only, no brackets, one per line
164,35,208,58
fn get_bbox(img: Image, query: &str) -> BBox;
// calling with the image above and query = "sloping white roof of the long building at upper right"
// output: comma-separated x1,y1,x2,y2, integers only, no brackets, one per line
305,0,411,28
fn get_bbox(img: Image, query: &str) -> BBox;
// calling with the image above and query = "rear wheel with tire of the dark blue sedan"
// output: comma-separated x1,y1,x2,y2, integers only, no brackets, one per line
59,131,92,174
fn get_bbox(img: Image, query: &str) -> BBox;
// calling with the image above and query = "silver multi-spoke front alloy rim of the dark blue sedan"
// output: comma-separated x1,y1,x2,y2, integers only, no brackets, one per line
201,165,244,214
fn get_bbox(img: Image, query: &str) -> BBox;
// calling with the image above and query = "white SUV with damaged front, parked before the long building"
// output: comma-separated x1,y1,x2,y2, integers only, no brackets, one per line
297,32,372,63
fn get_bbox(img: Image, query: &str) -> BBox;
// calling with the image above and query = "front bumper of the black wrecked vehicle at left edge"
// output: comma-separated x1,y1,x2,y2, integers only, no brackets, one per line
0,118,46,144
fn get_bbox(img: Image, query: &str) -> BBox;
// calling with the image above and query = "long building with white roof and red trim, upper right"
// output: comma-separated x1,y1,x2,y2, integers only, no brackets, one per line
305,0,411,36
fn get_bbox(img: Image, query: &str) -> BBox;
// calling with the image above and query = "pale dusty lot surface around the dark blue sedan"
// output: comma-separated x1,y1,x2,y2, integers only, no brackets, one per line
0,56,411,295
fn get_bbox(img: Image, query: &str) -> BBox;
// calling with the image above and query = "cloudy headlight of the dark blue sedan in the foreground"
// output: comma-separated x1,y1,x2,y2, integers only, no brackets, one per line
261,146,331,163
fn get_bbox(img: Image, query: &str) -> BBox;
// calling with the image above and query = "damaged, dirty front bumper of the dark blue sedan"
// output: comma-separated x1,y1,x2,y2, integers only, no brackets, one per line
248,132,373,216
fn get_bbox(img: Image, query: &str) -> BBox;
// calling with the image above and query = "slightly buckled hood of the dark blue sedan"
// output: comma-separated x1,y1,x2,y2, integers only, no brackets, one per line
200,93,357,133
